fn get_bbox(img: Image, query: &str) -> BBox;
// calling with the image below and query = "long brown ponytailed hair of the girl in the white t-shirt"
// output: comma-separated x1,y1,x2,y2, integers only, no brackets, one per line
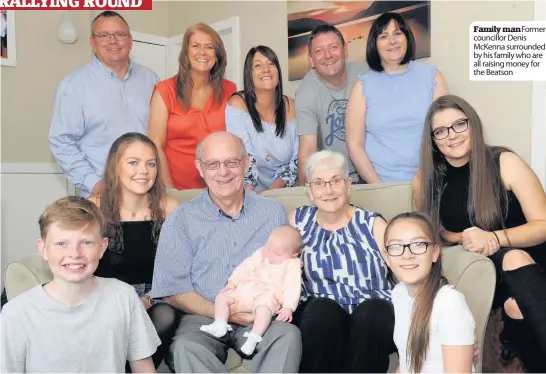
385,212,449,373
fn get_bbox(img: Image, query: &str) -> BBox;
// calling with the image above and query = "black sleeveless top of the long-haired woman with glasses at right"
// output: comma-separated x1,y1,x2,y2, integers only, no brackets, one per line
440,155,546,263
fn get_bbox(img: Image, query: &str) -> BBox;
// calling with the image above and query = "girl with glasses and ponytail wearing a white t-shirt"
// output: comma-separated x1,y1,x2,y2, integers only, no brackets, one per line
385,213,475,373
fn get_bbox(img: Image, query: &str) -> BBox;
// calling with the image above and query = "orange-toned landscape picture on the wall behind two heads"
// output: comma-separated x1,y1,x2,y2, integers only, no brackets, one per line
287,0,430,81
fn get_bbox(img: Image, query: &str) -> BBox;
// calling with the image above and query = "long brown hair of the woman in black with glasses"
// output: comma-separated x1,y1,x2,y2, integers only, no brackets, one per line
416,95,511,235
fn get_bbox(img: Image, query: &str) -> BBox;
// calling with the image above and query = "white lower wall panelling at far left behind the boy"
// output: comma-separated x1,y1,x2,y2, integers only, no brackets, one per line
0,163,75,289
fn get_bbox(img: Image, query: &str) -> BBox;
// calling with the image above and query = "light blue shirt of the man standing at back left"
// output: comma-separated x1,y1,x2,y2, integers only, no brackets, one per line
49,56,159,197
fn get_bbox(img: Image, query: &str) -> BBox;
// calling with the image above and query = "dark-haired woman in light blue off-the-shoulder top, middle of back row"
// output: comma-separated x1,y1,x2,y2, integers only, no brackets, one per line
226,45,299,192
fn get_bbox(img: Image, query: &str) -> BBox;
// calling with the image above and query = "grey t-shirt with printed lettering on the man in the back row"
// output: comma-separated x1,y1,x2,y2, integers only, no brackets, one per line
296,63,370,174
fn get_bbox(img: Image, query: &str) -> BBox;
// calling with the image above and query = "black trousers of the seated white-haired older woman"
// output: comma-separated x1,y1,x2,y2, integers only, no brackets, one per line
293,298,396,373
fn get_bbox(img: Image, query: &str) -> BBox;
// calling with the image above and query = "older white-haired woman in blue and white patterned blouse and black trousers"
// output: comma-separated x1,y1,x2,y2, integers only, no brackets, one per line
289,150,395,373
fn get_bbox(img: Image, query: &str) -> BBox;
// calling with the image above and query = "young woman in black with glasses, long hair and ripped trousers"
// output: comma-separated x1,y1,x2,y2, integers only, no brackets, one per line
413,95,546,372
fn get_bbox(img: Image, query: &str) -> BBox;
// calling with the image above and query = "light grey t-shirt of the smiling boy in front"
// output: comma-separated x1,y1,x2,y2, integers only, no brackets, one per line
0,277,161,373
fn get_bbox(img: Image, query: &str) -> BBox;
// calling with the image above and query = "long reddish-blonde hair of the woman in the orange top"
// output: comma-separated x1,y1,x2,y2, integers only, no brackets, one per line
176,23,227,111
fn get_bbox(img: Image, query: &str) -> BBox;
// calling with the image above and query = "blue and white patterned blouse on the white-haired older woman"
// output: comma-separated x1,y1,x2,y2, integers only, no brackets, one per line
295,206,391,313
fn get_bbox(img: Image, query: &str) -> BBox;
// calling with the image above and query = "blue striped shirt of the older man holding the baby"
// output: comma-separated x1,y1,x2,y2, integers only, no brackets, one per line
152,190,287,302
